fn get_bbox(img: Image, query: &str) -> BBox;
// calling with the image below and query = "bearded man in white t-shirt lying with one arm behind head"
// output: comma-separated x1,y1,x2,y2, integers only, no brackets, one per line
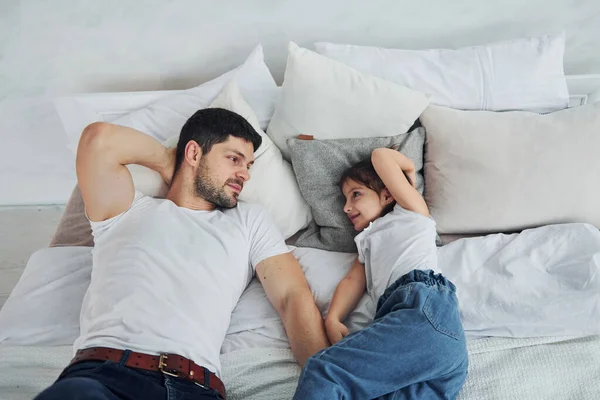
38,109,328,400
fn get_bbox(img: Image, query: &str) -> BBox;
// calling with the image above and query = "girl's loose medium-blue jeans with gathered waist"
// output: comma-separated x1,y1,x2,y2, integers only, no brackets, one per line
294,270,468,400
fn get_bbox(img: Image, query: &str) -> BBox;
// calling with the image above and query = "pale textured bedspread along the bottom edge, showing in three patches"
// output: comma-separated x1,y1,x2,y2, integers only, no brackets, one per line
0,336,600,400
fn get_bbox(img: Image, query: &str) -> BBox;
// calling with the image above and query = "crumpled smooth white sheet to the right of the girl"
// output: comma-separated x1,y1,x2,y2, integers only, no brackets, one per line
438,224,600,337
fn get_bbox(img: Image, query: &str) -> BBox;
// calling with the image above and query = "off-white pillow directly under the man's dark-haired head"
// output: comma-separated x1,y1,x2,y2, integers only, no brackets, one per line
164,80,312,239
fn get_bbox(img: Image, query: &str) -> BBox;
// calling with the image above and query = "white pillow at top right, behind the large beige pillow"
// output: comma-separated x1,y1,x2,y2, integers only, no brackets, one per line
315,32,569,112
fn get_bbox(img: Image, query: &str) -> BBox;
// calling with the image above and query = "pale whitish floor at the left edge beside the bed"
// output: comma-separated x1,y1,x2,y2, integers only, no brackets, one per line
0,206,64,308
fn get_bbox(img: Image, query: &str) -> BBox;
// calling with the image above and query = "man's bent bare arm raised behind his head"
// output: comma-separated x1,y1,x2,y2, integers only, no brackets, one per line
77,122,173,221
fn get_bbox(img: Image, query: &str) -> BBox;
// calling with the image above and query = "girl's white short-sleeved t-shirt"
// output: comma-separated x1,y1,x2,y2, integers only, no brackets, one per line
354,204,438,302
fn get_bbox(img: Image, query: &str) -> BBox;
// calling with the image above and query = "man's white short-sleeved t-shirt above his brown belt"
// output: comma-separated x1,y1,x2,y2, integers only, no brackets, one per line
74,193,289,375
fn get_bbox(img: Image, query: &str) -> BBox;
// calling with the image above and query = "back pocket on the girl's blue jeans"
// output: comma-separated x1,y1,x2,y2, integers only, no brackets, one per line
423,288,463,340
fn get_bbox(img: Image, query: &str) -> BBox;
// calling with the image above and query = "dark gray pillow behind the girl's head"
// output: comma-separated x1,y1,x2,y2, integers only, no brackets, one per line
287,128,425,253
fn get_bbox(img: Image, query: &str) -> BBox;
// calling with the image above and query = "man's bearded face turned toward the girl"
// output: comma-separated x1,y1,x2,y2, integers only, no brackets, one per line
194,136,254,208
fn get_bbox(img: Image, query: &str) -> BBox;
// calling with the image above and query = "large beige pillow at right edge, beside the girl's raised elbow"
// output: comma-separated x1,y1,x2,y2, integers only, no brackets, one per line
421,103,600,234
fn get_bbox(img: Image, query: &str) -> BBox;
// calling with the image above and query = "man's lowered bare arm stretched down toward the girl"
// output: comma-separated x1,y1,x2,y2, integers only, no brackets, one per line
256,253,329,366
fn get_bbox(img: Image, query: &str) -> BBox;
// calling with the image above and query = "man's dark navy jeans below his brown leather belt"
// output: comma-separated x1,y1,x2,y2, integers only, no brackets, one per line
35,354,221,400
